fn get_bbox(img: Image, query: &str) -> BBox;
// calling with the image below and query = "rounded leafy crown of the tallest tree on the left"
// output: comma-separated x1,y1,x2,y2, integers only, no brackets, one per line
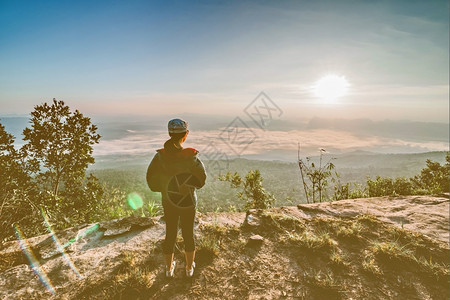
22,99,100,196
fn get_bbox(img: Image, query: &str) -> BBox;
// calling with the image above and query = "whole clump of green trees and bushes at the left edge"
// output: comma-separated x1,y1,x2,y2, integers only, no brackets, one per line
0,99,110,240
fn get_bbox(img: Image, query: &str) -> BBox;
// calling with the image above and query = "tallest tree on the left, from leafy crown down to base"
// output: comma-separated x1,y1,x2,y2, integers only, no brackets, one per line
22,99,102,227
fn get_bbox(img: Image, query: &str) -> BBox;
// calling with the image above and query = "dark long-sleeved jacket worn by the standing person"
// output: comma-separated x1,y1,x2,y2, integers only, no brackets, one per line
147,148,206,205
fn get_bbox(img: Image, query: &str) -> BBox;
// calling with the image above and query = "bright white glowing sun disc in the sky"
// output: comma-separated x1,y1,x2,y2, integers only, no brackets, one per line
312,74,350,103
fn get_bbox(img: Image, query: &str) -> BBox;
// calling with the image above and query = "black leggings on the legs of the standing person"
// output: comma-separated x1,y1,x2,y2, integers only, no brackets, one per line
163,204,195,254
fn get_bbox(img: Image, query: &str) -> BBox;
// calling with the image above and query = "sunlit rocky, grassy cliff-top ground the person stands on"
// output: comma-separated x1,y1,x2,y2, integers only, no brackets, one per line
0,195,450,299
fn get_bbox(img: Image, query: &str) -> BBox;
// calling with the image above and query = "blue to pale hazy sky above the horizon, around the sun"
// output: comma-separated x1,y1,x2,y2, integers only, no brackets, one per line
0,0,449,123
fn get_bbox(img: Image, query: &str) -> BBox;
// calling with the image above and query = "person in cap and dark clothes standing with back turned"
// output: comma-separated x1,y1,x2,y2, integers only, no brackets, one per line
147,119,206,278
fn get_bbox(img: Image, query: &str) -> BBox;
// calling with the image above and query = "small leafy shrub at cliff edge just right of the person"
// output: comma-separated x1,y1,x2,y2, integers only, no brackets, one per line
219,170,275,209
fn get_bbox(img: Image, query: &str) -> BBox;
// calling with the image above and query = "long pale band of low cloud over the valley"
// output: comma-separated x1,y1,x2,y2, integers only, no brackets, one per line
94,129,448,160
